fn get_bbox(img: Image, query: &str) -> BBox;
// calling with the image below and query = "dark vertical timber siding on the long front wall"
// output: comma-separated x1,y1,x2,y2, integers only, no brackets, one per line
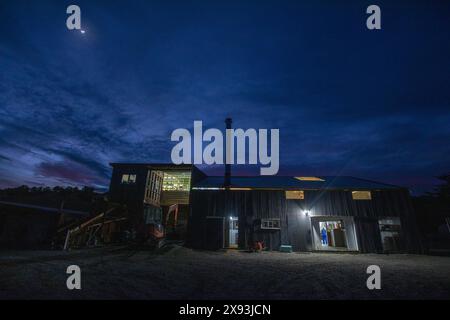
188,189,421,252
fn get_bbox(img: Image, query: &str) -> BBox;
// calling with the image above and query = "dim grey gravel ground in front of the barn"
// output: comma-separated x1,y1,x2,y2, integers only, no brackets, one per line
0,246,450,299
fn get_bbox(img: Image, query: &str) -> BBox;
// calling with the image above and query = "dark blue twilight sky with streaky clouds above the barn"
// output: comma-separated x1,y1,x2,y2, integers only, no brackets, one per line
0,0,450,191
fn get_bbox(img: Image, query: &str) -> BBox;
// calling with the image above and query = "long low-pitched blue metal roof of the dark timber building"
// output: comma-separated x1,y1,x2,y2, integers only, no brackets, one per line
193,176,401,190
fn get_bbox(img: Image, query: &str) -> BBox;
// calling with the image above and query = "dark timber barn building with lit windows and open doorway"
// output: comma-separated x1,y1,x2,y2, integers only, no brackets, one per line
110,163,421,253
